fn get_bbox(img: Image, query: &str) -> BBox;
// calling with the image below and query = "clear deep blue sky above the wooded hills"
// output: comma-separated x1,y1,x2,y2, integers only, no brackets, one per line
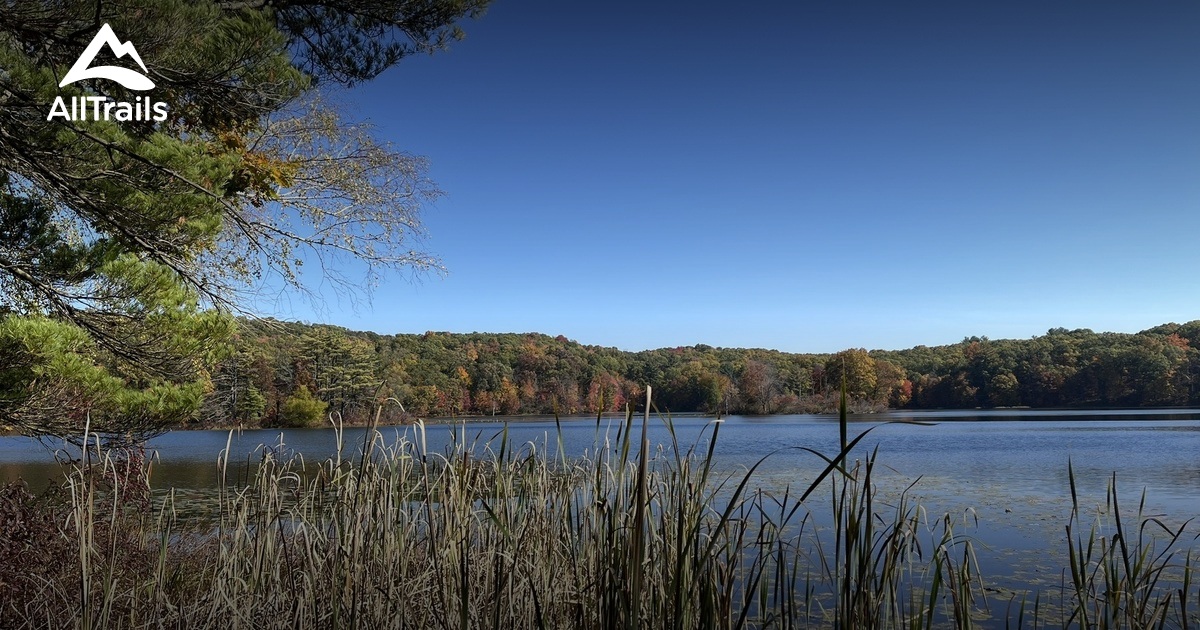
262,0,1200,352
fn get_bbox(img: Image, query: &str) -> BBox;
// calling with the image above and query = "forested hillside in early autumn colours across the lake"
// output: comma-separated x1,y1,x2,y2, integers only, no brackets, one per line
198,320,1200,425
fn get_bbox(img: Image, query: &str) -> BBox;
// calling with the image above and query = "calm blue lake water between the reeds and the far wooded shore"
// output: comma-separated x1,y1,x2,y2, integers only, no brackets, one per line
0,409,1200,607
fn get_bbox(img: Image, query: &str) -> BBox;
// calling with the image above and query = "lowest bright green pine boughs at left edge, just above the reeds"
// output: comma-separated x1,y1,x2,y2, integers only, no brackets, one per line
0,265,232,439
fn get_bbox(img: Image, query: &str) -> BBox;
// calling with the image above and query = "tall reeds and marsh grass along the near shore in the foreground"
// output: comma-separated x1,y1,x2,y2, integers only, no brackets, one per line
0,398,1196,629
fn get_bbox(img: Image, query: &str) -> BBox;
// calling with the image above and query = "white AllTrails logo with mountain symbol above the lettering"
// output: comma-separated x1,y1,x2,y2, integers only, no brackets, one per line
46,24,167,122
